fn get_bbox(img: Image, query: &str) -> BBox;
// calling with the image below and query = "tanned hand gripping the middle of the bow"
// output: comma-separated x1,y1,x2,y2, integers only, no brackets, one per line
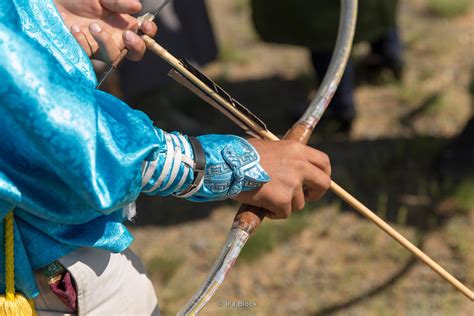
235,139,331,219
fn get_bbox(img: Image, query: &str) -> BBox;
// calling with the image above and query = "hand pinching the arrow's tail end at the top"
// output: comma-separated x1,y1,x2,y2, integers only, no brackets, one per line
54,0,157,63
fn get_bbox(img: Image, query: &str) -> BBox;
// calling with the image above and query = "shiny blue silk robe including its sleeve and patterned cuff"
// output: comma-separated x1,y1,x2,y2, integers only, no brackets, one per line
0,0,269,298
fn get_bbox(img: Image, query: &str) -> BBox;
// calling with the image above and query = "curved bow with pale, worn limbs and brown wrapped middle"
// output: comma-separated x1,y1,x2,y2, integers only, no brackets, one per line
178,0,358,315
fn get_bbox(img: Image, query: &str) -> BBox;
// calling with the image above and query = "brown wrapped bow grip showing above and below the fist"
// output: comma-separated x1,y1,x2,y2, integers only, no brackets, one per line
232,122,313,234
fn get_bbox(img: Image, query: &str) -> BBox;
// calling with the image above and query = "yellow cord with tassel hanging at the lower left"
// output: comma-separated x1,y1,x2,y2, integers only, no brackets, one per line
0,211,36,316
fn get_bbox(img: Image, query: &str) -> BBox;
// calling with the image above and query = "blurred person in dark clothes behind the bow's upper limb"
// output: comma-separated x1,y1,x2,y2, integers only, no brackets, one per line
252,0,403,133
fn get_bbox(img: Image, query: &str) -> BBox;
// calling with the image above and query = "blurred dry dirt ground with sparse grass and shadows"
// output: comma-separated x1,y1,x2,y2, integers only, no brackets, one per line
124,0,474,315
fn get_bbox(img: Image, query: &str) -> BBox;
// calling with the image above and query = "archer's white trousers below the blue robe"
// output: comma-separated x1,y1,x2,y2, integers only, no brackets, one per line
35,248,159,316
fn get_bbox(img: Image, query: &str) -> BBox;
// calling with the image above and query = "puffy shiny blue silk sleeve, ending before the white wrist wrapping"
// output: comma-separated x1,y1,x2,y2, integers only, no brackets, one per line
0,25,161,216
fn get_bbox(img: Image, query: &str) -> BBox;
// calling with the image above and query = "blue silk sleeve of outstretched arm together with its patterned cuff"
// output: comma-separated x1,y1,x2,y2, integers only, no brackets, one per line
0,3,268,214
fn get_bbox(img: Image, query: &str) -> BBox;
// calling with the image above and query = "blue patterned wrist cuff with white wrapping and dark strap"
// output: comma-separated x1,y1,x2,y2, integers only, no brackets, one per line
142,129,270,202
